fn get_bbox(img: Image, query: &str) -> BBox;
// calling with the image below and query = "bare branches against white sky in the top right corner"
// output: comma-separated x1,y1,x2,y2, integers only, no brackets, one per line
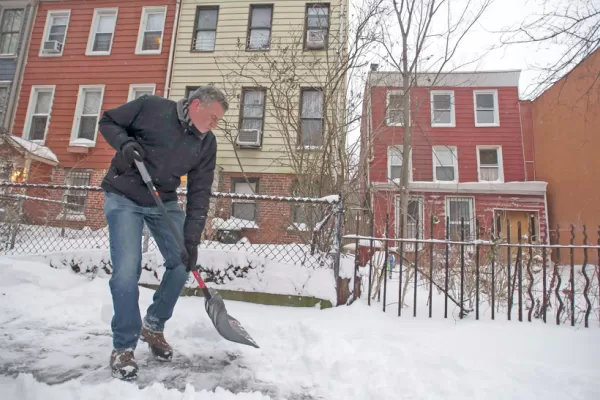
501,0,600,97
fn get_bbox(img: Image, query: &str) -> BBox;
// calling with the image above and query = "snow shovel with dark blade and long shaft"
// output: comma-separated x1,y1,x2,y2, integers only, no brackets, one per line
135,160,259,348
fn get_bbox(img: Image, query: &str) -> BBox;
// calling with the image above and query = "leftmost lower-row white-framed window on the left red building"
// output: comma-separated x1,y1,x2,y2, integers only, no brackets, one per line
23,86,55,142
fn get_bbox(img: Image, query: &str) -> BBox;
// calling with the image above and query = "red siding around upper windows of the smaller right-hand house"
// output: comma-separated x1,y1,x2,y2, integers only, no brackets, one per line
370,87,525,182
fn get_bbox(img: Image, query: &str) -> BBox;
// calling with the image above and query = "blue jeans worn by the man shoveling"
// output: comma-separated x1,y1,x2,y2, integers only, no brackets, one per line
104,192,189,351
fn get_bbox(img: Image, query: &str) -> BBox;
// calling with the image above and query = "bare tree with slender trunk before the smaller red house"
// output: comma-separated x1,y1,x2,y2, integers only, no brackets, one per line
363,0,493,300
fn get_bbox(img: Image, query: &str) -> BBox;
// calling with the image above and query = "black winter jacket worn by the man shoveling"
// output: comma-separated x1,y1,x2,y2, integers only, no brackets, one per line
99,95,217,244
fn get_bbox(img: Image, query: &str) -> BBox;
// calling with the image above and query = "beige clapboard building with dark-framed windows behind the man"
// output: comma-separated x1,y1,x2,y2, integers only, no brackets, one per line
167,0,348,205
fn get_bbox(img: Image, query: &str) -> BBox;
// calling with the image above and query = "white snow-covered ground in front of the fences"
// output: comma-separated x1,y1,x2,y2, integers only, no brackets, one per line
0,257,600,400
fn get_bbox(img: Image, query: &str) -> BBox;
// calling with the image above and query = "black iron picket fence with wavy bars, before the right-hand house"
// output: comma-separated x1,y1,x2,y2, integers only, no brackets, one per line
344,217,600,328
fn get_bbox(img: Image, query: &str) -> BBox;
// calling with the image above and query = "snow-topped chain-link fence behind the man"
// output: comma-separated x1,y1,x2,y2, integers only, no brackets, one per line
0,181,343,268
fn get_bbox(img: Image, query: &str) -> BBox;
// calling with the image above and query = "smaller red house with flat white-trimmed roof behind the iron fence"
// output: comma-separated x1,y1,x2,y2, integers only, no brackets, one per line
361,71,547,241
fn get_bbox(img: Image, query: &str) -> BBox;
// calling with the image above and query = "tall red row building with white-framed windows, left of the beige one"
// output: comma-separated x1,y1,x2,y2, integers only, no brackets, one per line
11,0,177,227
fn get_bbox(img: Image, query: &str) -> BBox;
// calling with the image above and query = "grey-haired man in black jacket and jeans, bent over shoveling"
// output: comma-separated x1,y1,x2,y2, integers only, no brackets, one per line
99,86,229,379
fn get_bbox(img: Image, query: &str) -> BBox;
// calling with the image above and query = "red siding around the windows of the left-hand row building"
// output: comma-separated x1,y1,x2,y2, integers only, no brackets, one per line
14,0,175,169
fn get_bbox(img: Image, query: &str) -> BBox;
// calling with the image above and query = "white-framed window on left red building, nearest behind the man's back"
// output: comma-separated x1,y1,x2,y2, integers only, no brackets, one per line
71,85,104,146
